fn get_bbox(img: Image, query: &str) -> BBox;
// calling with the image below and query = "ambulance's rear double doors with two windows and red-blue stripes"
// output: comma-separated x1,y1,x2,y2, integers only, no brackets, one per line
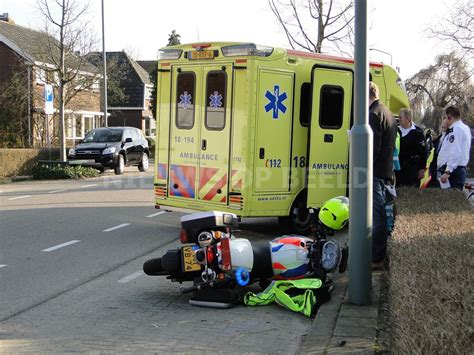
168,63,232,204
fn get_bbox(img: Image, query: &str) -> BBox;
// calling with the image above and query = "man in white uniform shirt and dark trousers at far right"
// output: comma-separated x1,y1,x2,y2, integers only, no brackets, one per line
437,106,471,190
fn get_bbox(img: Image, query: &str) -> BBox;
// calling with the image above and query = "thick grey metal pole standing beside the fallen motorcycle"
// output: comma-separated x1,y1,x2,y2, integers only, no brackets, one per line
349,0,373,305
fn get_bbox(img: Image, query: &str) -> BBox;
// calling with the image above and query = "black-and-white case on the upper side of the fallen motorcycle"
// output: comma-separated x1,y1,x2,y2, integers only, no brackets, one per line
181,211,238,233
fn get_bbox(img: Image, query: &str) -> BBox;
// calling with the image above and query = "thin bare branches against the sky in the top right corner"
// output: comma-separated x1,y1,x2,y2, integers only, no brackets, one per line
429,0,474,55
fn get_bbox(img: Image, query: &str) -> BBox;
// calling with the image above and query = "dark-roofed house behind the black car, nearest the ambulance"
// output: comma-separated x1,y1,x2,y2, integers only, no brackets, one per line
89,51,155,138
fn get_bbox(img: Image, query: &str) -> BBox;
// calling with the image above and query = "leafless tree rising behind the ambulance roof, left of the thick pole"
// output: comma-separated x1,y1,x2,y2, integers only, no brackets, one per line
268,0,354,56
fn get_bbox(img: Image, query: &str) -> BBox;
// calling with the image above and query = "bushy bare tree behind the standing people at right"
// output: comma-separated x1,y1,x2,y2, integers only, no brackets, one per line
405,52,474,130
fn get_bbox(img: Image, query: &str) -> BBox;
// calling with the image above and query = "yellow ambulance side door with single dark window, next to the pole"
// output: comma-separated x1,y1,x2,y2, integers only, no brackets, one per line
307,66,353,207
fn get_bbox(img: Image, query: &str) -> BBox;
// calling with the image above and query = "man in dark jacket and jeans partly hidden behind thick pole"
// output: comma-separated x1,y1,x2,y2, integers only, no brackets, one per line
369,82,397,270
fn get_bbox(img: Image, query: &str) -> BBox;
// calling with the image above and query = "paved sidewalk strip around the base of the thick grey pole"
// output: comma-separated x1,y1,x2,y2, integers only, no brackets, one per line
300,271,382,354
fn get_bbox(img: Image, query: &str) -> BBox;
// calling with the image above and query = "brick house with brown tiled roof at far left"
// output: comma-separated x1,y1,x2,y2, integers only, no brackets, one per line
0,14,104,147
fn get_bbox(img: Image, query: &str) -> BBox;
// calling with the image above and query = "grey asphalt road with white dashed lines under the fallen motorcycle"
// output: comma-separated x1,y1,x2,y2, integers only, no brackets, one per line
0,169,311,353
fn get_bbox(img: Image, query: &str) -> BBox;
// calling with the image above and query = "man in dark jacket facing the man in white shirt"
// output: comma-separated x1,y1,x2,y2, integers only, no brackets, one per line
395,108,428,187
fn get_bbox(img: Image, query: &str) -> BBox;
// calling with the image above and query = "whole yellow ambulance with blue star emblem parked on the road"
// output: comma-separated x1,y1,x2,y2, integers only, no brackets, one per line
154,42,409,232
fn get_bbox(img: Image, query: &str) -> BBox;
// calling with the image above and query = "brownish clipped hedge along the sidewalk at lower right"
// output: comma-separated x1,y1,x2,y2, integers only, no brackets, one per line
388,188,474,354
